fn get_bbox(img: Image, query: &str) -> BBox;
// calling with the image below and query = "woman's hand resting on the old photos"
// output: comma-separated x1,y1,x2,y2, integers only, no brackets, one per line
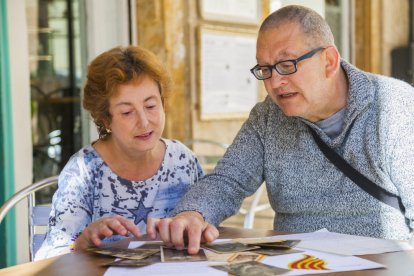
74,215,142,250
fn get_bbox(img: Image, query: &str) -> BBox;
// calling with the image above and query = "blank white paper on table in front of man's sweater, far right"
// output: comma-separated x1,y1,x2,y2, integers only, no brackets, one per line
266,229,413,256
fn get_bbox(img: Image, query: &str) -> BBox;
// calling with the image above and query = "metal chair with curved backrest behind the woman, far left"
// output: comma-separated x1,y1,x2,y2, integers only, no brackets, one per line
0,176,58,261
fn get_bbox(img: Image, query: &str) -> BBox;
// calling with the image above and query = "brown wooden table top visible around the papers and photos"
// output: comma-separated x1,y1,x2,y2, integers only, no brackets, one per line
0,228,414,276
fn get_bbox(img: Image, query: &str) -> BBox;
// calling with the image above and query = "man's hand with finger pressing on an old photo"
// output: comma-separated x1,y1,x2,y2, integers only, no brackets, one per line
147,211,219,254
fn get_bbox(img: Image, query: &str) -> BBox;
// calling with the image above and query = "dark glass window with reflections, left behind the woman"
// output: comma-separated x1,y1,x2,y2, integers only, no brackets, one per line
26,0,82,202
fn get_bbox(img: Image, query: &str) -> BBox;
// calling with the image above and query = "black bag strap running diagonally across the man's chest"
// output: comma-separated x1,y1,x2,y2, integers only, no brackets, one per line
309,127,405,214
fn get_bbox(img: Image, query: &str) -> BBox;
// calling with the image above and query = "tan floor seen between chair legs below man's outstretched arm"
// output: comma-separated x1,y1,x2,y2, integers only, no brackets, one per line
220,185,274,229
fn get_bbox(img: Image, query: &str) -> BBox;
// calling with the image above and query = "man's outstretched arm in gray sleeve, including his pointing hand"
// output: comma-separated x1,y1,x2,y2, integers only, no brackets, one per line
147,100,268,253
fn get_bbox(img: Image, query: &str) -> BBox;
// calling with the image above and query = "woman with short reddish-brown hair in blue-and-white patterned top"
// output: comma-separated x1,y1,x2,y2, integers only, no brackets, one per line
36,46,203,259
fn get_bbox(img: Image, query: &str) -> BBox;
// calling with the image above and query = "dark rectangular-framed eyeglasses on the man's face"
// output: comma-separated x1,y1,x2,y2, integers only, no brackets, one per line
250,47,325,80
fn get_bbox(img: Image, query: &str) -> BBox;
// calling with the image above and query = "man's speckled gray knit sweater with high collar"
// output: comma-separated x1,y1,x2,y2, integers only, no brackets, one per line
175,61,414,240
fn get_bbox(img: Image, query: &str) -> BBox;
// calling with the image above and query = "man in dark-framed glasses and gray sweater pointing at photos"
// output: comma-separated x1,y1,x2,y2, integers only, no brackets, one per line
147,6,414,253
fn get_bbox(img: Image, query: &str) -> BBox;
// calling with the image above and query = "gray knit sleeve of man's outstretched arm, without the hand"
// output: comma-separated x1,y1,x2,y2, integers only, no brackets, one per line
173,103,268,226
